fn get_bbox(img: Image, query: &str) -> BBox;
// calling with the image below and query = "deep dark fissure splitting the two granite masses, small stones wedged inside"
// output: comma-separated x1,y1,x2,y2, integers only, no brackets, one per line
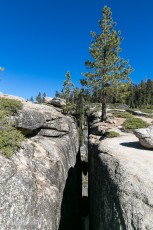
58,119,89,230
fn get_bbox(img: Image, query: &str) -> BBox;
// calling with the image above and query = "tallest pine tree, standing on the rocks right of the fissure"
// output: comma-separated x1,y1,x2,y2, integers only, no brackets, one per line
85,6,132,121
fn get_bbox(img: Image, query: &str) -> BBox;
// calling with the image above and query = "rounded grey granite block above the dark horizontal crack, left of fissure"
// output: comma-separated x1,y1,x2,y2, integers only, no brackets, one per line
14,102,71,135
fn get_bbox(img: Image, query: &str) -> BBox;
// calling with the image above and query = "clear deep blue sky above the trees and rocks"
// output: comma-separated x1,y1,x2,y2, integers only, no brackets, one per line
0,0,153,98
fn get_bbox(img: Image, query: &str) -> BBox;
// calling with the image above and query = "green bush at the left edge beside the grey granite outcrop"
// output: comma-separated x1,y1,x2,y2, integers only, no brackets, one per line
0,98,24,157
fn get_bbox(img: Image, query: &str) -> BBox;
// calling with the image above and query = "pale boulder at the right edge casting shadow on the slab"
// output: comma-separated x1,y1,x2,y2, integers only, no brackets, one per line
134,126,153,149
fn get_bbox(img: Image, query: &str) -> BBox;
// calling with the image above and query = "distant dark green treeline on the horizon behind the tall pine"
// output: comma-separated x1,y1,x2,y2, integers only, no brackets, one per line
55,79,153,108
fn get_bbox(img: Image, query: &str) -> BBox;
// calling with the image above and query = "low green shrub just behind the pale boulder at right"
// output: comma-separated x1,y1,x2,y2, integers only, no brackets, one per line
123,117,149,131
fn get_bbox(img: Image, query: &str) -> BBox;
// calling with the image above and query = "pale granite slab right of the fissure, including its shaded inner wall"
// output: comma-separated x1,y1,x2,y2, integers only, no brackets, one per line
89,134,153,230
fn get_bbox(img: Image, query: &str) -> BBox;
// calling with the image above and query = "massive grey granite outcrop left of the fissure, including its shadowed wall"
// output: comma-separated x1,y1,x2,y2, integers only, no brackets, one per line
0,99,81,230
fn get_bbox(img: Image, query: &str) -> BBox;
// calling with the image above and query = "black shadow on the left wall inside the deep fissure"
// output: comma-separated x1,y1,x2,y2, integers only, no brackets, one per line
58,153,82,230
